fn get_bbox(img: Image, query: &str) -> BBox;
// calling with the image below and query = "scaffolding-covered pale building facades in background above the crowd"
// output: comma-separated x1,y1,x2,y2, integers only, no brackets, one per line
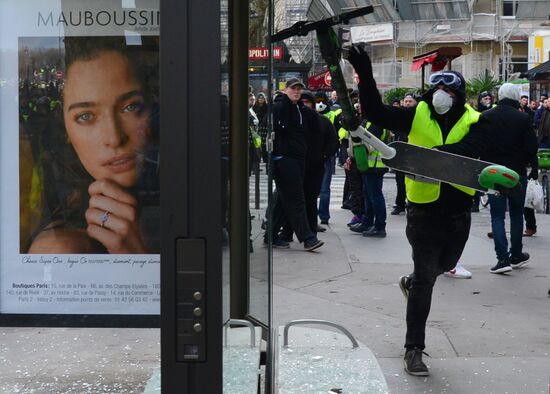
307,0,550,90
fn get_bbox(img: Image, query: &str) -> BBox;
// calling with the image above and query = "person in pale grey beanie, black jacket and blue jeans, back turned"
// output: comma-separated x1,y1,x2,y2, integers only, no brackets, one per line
481,83,538,274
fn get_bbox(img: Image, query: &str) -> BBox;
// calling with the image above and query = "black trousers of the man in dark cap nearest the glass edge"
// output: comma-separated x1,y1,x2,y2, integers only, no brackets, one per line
273,157,314,242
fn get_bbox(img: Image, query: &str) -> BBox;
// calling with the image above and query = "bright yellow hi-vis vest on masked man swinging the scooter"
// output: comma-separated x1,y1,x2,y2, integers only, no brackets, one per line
405,101,481,204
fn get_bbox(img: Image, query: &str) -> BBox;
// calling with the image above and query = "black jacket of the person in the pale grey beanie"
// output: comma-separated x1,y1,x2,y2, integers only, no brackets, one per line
481,99,538,176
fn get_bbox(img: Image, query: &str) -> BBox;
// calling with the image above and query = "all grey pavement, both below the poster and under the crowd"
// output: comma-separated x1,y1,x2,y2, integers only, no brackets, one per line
0,179,550,394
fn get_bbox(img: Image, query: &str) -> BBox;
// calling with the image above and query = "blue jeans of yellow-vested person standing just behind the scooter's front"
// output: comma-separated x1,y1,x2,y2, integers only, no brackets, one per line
362,173,386,230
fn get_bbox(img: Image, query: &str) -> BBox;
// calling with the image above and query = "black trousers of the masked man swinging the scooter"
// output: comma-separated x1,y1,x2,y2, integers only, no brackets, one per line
405,205,471,349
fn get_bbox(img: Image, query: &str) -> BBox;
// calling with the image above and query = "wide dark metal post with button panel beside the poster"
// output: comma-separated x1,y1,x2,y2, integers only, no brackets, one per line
159,0,223,394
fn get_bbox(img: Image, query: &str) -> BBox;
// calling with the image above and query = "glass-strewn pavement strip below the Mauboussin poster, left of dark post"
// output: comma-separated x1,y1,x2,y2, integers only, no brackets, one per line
0,327,160,394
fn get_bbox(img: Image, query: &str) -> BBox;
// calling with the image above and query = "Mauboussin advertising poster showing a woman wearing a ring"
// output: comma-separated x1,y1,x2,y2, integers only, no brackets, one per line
0,0,160,315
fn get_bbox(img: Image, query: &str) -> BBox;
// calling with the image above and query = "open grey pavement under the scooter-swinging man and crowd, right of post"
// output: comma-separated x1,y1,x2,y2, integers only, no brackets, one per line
273,183,550,394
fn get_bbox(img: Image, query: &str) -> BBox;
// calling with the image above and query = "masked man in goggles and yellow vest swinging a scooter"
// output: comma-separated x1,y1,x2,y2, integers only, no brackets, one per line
349,46,493,376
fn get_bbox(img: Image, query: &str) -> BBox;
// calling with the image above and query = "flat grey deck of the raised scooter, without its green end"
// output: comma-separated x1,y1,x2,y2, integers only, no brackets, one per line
382,141,494,192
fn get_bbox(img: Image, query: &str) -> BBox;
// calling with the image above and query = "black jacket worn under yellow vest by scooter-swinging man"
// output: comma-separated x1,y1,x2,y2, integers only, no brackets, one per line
356,70,492,214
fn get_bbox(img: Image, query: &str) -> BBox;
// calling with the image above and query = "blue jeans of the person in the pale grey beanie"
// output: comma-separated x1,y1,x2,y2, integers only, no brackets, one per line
489,177,527,260
